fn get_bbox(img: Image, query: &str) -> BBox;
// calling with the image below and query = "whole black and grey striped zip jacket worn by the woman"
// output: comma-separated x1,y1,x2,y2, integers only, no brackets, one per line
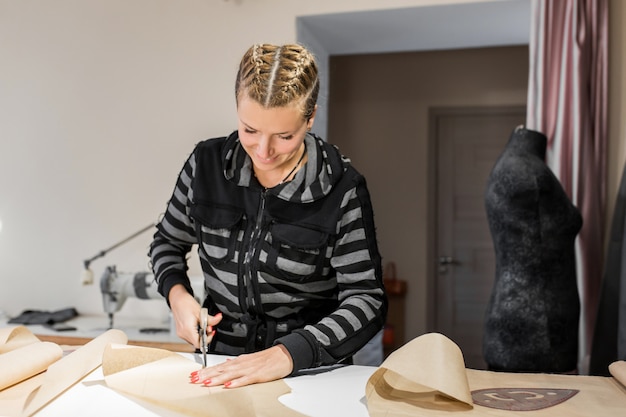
150,132,387,372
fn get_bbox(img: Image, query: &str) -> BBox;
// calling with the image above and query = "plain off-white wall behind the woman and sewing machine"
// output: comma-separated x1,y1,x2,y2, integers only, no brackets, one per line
0,0,480,322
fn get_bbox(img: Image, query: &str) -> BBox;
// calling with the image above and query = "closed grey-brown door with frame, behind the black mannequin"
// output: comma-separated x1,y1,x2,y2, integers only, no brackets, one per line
429,106,526,369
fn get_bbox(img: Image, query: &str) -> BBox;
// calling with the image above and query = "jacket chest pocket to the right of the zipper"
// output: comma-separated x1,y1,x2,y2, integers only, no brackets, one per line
267,223,329,282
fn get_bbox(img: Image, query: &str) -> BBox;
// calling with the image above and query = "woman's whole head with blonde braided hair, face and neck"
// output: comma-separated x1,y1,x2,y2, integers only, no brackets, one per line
235,44,319,188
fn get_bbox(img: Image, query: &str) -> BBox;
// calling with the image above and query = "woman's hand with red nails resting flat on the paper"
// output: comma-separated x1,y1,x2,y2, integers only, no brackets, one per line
189,344,293,388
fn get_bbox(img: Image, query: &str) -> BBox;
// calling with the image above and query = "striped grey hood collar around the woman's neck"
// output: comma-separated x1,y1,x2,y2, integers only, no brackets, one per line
222,131,350,203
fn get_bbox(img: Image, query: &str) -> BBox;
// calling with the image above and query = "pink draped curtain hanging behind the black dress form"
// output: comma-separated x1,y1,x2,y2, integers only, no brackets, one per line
527,0,608,373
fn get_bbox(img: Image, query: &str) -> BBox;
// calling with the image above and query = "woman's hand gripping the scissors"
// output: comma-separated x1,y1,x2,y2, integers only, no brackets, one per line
168,285,222,349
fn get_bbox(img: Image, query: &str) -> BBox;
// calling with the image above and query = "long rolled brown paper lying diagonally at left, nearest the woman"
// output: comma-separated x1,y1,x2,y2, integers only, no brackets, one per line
0,329,128,417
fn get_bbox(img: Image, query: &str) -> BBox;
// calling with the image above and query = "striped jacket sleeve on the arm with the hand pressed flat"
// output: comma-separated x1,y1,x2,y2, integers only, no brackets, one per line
277,177,387,372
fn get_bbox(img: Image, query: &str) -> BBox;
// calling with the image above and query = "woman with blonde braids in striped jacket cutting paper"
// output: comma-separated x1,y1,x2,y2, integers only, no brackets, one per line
150,44,387,387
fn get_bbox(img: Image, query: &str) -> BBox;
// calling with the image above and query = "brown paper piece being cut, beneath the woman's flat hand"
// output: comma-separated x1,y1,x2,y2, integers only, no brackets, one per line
102,345,302,417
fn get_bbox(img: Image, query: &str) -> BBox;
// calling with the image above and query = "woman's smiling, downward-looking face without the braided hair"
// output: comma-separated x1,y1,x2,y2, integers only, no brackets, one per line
237,97,313,176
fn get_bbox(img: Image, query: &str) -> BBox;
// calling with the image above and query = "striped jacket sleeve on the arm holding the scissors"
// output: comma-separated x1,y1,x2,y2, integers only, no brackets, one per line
149,151,196,305
